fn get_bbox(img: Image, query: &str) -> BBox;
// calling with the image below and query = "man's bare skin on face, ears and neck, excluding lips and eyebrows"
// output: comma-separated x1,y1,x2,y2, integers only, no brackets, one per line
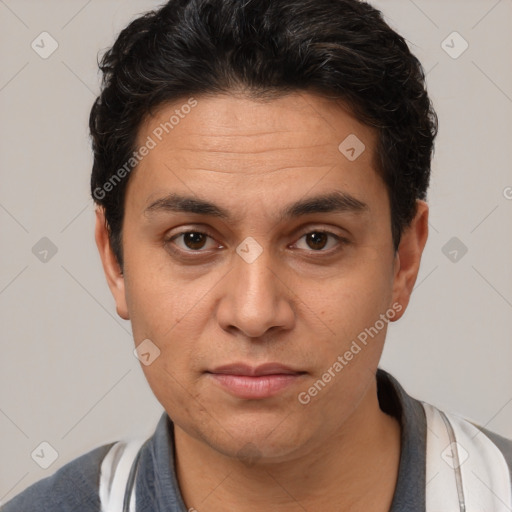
96,92,428,512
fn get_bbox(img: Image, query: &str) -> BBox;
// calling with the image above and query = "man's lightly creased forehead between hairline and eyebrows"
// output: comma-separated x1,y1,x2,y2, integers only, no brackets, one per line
127,92,384,217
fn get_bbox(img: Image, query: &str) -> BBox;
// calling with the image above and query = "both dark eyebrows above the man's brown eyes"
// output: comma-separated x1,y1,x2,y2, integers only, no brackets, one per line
144,190,369,221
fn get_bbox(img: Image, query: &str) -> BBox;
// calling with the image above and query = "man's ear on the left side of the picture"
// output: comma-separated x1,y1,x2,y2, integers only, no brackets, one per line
95,207,130,320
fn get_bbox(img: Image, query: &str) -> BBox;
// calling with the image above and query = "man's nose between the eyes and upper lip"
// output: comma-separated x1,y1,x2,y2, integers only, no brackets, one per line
217,243,295,338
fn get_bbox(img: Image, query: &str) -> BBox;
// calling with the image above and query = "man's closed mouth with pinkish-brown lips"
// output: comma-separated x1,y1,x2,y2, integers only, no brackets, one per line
206,363,307,400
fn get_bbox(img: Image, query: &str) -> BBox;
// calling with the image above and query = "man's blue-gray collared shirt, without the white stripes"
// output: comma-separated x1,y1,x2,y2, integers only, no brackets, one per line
1,369,512,512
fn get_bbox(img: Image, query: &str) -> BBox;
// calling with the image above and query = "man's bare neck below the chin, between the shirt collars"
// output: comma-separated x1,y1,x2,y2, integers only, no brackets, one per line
175,381,400,512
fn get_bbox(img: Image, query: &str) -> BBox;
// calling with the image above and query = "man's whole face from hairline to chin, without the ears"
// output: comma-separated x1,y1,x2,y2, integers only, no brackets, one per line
99,93,416,460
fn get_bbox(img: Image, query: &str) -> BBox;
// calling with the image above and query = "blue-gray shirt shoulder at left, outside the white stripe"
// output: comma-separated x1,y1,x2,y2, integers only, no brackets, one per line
1,444,112,512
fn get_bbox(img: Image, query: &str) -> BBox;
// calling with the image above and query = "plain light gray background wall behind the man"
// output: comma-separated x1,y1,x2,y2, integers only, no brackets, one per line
0,0,512,502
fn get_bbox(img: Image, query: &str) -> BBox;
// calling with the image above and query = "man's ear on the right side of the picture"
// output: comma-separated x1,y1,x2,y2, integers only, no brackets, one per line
393,200,428,321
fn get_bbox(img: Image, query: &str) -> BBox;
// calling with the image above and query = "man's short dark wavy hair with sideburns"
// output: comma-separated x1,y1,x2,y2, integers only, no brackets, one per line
89,0,437,271
